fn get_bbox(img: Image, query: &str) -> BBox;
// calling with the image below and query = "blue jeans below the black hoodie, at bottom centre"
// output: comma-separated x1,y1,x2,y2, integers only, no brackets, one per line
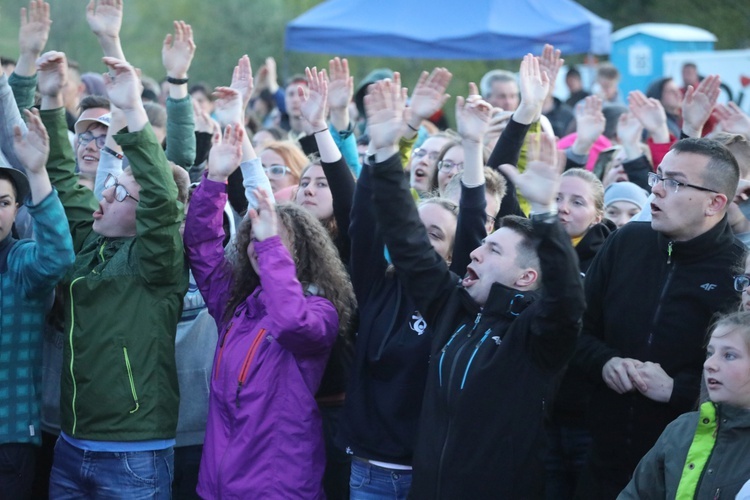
349,457,411,500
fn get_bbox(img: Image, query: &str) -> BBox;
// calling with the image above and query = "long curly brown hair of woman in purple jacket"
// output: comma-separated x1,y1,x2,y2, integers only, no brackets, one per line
225,203,356,335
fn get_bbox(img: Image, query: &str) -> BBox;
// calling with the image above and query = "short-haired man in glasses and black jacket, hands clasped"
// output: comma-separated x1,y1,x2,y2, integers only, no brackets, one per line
572,139,744,499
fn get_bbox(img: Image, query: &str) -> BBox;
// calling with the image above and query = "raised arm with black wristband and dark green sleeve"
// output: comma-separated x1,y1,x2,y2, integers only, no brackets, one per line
161,21,195,169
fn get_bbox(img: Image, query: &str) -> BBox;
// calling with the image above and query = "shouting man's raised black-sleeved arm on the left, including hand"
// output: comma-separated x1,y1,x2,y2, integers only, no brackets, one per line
365,80,456,323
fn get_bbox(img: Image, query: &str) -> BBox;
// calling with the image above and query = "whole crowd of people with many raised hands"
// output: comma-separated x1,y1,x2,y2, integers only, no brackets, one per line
0,0,750,500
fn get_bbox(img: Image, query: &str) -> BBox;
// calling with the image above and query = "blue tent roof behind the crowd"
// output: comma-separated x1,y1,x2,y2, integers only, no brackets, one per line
286,0,612,60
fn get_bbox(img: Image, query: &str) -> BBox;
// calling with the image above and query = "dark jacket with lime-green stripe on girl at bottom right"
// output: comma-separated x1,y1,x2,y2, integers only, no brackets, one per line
617,402,750,500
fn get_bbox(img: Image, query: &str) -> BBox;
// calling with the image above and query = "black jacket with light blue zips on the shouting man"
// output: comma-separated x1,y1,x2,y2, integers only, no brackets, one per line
372,156,584,500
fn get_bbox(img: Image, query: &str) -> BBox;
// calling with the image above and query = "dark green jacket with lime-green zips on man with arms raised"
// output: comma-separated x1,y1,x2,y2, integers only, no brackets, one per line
41,109,188,441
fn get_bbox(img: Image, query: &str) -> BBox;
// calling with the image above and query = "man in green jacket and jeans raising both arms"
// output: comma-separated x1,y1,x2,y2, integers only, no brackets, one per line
37,52,188,498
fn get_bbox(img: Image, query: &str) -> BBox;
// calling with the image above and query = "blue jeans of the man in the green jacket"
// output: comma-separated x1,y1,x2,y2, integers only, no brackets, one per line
49,438,174,500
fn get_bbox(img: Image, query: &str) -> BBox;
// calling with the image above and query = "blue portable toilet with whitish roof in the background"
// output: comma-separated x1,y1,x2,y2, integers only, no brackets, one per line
610,23,716,96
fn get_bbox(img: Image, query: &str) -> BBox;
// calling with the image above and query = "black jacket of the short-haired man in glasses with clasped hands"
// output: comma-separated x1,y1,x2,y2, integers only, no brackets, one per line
572,217,744,480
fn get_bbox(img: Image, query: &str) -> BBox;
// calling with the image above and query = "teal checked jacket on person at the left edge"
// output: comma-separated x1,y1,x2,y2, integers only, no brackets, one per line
0,191,75,445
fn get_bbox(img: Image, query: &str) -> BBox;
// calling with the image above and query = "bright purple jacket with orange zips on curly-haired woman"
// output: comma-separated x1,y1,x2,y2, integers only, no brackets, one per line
185,178,338,499
